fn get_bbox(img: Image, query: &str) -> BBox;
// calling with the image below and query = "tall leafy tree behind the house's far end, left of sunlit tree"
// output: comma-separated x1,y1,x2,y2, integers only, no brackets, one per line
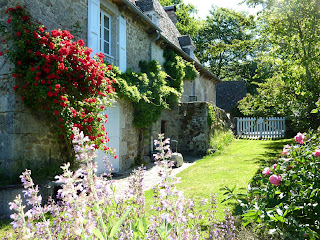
195,7,257,86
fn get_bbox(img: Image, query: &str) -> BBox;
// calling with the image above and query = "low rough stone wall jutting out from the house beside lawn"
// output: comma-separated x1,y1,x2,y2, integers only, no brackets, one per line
152,102,229,156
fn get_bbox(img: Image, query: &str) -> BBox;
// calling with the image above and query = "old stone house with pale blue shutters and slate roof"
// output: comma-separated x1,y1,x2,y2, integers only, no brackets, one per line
0,0,220,176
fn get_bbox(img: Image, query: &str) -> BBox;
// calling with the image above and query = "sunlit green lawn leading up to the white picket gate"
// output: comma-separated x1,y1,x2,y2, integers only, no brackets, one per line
178,139,291,219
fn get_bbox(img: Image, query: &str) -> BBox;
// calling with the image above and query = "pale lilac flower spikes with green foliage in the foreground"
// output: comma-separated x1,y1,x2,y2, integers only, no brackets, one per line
5,128,234,239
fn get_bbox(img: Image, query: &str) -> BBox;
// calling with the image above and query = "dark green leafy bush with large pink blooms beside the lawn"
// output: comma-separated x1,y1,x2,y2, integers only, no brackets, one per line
230,132,320,239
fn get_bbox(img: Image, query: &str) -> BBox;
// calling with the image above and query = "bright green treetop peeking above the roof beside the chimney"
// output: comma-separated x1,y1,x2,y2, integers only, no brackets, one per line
160,0,201,37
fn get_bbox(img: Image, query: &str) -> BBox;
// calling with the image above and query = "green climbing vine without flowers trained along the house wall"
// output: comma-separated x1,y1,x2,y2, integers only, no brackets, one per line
113,50,198,128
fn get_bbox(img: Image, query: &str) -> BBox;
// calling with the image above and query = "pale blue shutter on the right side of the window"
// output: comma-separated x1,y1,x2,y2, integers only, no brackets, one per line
119,16,127,72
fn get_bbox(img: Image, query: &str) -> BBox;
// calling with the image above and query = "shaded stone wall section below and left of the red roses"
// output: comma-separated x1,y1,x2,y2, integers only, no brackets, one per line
0,74,63,180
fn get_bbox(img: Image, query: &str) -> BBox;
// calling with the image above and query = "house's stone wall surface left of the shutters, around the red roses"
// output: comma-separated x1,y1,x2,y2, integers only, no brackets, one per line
0,0,88,180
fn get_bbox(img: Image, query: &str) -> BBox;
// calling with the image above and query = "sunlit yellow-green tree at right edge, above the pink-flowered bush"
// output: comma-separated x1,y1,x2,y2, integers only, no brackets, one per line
240,0,320,131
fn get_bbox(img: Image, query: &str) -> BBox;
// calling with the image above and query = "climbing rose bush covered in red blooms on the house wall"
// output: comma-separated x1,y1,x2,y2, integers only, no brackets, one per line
1,6,115,158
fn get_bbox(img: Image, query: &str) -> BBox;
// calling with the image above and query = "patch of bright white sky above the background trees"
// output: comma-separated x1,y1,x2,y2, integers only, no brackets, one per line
183,0,260,19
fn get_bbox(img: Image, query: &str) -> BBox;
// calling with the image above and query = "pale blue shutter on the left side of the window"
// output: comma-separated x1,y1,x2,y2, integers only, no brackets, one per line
88,0,100,55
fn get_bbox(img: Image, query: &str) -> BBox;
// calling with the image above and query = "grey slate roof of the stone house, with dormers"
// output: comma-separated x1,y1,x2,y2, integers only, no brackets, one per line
112,0,221,83
